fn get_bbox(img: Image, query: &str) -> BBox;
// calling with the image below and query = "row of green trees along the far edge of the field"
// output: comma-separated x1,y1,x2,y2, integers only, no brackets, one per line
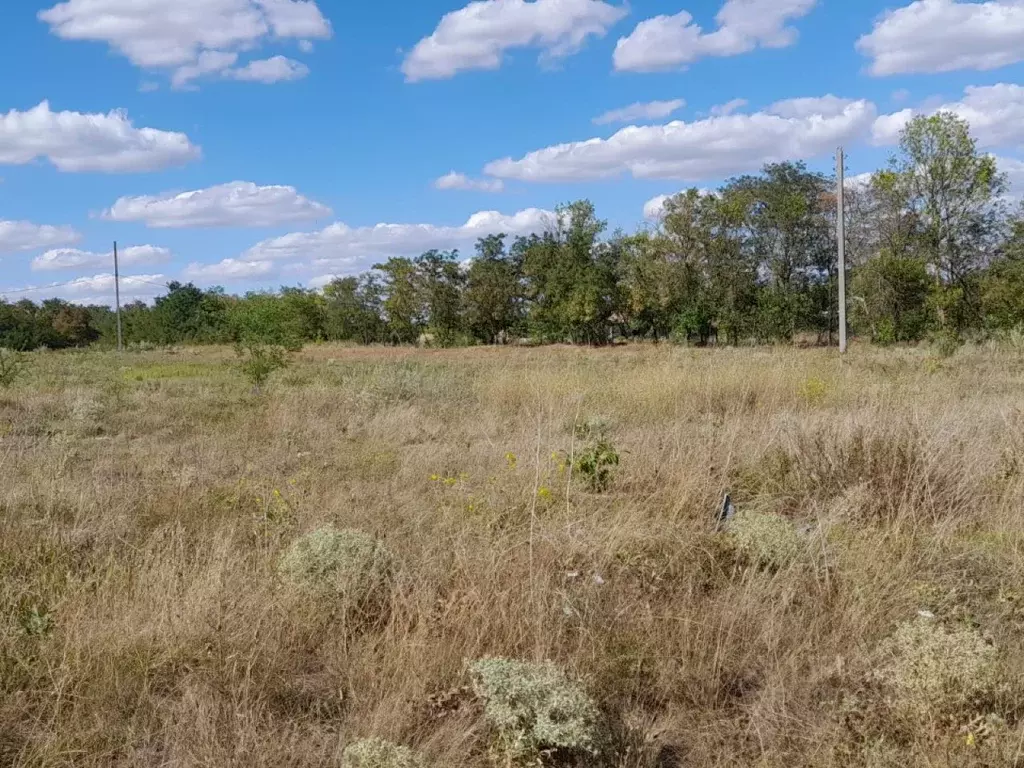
0,113,1024,350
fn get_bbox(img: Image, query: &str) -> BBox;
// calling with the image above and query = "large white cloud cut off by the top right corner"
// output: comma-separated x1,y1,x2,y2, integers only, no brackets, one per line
857,0,1024,76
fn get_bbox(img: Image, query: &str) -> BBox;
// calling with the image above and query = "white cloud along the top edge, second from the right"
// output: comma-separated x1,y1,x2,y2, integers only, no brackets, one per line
613,0,817,72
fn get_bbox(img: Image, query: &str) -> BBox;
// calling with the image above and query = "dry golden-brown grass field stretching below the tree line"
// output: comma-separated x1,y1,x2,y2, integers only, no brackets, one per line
0,345,1024,768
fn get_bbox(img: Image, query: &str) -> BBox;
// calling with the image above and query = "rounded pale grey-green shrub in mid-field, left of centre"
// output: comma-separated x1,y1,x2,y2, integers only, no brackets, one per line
279,526,393,606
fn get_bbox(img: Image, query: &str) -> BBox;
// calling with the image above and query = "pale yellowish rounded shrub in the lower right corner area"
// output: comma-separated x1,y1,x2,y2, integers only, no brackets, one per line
874,616,998,724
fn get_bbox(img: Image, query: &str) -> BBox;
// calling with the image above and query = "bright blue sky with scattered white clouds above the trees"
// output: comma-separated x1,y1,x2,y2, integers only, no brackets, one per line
0,0,1024,302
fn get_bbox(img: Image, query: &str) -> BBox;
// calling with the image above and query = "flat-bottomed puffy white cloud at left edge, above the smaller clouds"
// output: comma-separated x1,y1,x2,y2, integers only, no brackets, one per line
0,101,200,173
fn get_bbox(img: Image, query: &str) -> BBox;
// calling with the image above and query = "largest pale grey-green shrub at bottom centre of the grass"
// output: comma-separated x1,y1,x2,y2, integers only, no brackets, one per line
470,658,598,764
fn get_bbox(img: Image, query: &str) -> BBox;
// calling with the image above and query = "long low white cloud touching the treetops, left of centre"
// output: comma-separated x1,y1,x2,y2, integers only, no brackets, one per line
242,208,554,272
